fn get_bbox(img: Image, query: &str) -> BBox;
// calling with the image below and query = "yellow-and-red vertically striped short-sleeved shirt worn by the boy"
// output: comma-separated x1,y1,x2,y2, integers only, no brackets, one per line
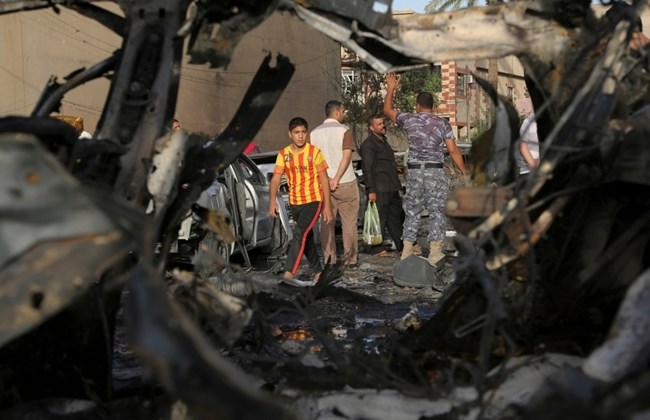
273,143,328,205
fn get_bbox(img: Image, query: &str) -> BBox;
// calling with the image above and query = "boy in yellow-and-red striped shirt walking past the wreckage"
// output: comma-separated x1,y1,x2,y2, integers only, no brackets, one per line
269,117,332,286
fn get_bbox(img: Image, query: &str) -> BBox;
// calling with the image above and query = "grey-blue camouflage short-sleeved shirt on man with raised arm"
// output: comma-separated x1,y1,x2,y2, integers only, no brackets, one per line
397,112,454,163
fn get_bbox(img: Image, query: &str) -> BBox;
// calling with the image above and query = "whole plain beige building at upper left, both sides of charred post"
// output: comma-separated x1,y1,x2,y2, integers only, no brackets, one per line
0,2,341,150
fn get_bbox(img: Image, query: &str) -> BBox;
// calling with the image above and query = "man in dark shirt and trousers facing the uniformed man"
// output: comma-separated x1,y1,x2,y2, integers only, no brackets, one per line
359,114,404,255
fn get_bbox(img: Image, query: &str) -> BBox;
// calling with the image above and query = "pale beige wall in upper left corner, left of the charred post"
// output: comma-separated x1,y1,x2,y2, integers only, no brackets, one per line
0,3,121,133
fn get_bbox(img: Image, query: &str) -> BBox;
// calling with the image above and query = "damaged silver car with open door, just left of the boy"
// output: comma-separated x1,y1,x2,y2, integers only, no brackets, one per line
172,154,291,265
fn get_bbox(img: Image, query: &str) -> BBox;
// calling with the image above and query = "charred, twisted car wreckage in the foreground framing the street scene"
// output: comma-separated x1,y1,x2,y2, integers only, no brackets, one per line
0,0,650,419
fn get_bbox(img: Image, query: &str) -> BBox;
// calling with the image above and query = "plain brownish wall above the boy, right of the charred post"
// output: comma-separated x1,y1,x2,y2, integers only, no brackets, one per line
176,13,341,151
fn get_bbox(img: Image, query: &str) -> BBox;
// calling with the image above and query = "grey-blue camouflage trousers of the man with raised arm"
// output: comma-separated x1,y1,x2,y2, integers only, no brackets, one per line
402,168,449,242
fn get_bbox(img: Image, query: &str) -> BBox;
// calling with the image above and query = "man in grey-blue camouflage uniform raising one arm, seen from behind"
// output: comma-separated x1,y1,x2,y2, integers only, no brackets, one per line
384,73,466,265
